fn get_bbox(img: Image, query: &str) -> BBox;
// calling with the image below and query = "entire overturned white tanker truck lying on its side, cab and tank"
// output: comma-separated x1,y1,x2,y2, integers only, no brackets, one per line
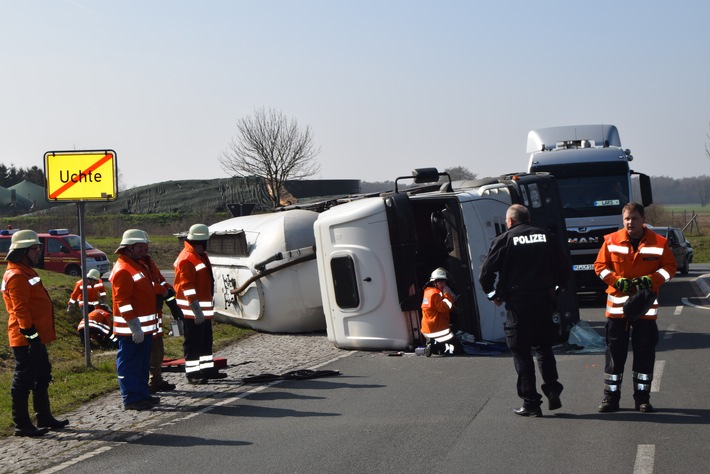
204,168,579,350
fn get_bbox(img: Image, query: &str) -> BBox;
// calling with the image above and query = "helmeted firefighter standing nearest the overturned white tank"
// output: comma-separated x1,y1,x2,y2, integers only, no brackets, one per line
175,224,227,384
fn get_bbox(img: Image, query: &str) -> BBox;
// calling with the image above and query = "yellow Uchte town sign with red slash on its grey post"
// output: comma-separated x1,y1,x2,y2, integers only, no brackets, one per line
44,150,118,367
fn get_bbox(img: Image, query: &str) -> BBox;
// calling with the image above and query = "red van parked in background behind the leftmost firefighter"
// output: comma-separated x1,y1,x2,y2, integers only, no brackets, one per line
0,229,111,276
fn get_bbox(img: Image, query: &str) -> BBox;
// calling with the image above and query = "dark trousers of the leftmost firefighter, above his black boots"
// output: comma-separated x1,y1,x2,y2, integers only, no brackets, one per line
10,344,52,397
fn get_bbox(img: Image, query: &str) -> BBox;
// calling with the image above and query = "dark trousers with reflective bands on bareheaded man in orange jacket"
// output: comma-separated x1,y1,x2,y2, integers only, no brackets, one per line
604,318,658,403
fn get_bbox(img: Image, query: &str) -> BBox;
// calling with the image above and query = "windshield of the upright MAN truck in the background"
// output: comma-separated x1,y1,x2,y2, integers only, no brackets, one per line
557,176,629,217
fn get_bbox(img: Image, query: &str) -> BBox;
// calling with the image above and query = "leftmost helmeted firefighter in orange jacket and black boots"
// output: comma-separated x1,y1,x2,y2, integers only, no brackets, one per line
2,230,69,436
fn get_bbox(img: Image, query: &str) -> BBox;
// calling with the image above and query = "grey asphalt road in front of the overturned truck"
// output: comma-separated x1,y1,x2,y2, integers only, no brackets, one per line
43,265,710,474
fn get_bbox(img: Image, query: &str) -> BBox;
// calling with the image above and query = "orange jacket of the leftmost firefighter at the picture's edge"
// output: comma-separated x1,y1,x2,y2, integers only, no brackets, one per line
2,262,57,347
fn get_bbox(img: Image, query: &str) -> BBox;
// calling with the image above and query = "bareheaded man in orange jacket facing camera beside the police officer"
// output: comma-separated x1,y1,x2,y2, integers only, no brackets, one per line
594,202,677,412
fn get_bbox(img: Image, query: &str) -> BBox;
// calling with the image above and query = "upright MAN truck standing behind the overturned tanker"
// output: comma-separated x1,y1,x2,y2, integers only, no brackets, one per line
527,125,653,294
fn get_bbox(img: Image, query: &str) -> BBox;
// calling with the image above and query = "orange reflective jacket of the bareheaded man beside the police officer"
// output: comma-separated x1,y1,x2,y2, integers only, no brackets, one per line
594,228,677,319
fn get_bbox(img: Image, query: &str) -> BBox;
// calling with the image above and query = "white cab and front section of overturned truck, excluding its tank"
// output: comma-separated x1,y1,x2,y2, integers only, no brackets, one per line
314,168,579,350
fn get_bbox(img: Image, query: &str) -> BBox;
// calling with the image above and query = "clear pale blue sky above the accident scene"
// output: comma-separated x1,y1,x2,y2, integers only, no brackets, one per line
0,0,710,187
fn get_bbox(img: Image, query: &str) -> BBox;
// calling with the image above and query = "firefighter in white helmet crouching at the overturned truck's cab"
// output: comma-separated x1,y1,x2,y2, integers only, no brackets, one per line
421,268,462,357
